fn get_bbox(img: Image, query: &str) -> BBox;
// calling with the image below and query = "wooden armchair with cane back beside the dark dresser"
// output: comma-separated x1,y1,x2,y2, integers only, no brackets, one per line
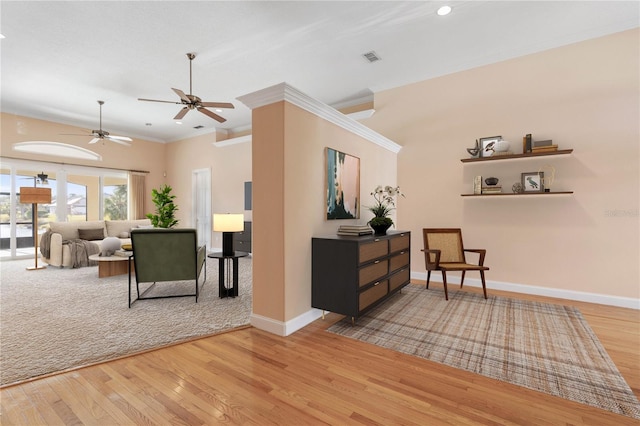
422,228,489,300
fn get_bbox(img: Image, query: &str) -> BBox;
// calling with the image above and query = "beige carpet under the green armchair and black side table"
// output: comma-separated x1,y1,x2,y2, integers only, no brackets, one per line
0,257,252,385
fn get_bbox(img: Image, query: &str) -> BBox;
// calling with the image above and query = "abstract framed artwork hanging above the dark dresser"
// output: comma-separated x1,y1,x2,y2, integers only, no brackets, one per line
325,148,360,220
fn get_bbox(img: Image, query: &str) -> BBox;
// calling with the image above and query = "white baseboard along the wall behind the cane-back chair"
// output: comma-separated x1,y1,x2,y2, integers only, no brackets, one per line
411,271,640,310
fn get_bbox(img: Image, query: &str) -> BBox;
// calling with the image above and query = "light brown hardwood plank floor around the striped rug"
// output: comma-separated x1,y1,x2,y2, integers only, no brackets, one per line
0,284,640,425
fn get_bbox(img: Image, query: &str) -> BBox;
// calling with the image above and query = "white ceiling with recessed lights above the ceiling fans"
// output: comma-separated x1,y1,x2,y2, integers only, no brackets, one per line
0,0,640,143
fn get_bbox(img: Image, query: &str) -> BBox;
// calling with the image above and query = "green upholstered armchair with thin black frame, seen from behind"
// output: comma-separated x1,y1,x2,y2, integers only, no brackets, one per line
129,228,207,307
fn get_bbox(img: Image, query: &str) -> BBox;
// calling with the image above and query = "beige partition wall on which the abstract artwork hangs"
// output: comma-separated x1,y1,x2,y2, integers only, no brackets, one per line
253,102,397,322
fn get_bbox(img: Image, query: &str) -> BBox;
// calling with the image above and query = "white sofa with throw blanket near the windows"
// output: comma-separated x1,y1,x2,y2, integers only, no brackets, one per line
42,219,151,268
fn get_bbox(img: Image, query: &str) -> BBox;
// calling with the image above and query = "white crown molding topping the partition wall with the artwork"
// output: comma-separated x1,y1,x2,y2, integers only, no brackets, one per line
236,83,402,154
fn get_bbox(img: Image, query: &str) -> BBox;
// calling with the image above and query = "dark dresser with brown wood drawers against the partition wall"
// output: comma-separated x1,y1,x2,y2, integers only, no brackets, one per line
311,231,411,321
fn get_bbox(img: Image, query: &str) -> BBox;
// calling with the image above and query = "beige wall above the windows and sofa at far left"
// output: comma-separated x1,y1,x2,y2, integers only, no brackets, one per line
0,113,165,213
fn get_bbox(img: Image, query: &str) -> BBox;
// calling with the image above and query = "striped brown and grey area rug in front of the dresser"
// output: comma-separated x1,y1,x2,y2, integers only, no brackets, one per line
328,285,640,418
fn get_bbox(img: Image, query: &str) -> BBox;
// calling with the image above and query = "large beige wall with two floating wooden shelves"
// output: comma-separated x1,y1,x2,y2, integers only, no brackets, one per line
363,30,640,298
